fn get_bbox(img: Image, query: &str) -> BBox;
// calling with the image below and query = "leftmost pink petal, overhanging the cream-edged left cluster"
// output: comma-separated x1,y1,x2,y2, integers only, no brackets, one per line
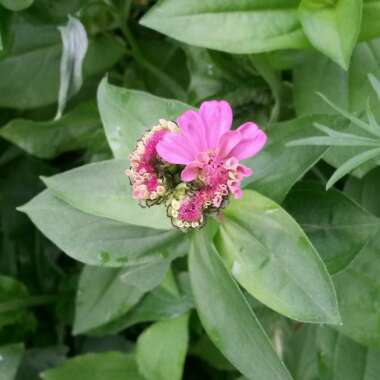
156,132,194,165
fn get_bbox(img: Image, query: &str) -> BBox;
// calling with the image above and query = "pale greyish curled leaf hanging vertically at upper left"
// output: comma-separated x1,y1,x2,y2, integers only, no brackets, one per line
55,16,88,119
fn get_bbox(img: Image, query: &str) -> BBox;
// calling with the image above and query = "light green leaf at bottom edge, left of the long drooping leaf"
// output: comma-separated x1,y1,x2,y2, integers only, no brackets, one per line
136,314,189,380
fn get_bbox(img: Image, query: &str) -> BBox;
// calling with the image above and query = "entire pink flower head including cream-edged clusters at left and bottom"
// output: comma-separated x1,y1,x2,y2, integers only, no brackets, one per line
127,100,267,230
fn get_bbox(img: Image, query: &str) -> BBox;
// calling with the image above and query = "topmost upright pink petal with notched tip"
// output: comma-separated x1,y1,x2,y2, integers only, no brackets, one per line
199,100,232,149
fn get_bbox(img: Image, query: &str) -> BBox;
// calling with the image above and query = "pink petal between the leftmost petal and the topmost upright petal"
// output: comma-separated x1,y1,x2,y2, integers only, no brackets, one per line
177,110,207,152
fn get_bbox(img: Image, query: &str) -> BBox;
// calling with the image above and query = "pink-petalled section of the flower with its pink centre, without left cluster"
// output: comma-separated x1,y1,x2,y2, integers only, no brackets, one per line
156,100,267,202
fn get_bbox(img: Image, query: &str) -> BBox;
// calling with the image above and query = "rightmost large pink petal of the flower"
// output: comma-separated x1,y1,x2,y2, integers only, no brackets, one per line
230,122,267,160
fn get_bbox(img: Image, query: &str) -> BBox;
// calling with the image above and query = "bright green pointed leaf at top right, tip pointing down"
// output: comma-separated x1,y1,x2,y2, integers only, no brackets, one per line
299,0,363,70
